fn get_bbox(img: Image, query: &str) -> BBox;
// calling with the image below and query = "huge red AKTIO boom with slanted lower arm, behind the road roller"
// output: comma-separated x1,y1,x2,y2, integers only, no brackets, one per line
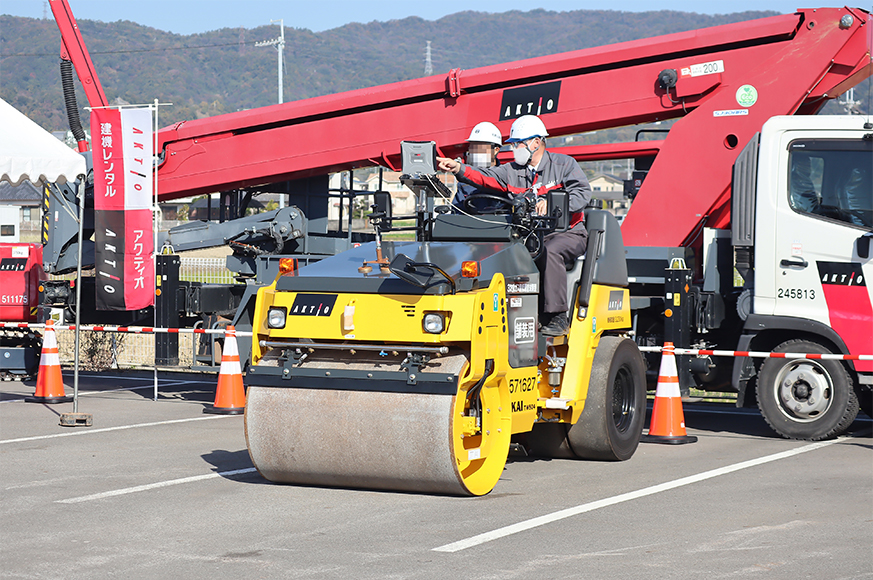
153,8,871,246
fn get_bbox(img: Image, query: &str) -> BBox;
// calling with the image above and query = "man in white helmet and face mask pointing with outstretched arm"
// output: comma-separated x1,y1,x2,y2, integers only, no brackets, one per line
437,115,591,336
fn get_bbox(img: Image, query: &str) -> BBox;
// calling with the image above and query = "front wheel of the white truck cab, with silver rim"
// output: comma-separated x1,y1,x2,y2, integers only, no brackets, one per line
757,340,858,441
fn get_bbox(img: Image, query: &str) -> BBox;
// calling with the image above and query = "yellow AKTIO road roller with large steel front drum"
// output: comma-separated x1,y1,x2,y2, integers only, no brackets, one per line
245,176,646,495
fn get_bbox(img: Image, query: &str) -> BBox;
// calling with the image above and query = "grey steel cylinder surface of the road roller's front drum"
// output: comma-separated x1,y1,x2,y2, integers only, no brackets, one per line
245,387,470,495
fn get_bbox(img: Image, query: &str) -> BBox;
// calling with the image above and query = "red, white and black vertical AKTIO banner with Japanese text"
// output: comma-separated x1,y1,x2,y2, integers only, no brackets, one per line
91,108,155,310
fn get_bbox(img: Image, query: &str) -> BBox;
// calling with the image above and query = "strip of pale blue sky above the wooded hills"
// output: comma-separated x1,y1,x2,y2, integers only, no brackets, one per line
0,0,871,34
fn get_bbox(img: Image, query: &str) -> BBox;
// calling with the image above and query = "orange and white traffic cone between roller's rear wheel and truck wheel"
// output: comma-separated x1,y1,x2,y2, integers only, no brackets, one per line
640,342,697,445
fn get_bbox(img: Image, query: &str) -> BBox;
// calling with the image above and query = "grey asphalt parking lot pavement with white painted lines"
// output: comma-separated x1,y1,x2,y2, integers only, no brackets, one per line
0,371,873,580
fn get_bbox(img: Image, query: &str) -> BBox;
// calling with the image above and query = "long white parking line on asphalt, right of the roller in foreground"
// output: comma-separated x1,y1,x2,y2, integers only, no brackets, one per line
432,437,847,552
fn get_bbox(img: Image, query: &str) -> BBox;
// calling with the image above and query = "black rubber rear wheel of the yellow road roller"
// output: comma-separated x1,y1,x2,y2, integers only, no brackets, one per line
567,336,646,461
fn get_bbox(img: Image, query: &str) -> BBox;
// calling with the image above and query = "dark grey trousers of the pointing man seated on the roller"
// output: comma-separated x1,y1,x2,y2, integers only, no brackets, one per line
536,229,588,313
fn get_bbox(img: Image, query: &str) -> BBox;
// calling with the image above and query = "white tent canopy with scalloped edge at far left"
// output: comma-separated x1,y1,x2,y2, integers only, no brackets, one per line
0,99,85,185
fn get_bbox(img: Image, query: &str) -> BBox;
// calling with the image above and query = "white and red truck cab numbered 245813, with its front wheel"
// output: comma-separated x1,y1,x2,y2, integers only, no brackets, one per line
732,116,873,439
